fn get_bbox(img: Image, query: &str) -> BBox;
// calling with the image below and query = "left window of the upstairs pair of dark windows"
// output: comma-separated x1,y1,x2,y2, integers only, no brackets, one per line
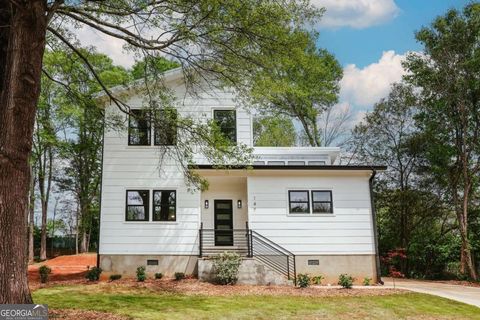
128,109,150,146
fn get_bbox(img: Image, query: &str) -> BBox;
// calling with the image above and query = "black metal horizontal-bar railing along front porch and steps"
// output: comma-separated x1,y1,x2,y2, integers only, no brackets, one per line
199,223,297,284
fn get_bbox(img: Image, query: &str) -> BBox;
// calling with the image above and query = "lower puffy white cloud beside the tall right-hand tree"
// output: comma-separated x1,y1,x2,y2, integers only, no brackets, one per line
340,50,405,108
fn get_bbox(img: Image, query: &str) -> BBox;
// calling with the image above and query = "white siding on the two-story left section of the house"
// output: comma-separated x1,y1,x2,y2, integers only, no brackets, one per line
99,81,252,255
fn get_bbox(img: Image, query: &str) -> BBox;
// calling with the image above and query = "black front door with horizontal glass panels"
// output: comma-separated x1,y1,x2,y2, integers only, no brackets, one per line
214,200,233,246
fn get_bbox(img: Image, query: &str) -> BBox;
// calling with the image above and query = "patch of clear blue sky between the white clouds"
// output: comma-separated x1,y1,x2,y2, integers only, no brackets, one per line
318,0,469,68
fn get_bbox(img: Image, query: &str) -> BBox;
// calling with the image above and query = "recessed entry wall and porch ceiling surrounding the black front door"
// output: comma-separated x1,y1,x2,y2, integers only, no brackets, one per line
201,176,248,229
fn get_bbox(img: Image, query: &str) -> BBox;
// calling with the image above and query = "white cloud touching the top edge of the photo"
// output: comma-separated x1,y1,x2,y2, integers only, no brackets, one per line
312,0,400,29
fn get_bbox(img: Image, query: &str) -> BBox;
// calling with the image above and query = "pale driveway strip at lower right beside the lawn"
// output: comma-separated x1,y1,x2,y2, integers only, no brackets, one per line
382,278,480,308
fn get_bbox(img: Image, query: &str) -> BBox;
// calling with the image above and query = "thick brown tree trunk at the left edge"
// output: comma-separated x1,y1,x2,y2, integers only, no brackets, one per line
0,0,47,304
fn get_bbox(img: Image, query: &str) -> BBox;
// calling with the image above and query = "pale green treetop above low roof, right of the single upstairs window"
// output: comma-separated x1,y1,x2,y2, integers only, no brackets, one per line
253,116,297,147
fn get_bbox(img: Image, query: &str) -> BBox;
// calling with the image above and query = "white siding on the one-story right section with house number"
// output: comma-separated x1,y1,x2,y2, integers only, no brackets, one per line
247,172,375,255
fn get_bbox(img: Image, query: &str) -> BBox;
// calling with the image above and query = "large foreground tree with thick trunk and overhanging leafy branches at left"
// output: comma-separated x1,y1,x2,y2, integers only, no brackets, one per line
0,0,319,303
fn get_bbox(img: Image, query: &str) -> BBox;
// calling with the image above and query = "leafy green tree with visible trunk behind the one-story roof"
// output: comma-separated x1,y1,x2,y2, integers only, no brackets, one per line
247,33,343,147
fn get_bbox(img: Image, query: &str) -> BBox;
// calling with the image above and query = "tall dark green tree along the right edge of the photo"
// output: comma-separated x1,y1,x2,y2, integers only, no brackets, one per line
405,3,480,280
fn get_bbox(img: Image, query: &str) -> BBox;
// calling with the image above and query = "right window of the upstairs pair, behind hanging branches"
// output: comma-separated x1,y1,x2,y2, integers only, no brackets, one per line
154,109,178,146
